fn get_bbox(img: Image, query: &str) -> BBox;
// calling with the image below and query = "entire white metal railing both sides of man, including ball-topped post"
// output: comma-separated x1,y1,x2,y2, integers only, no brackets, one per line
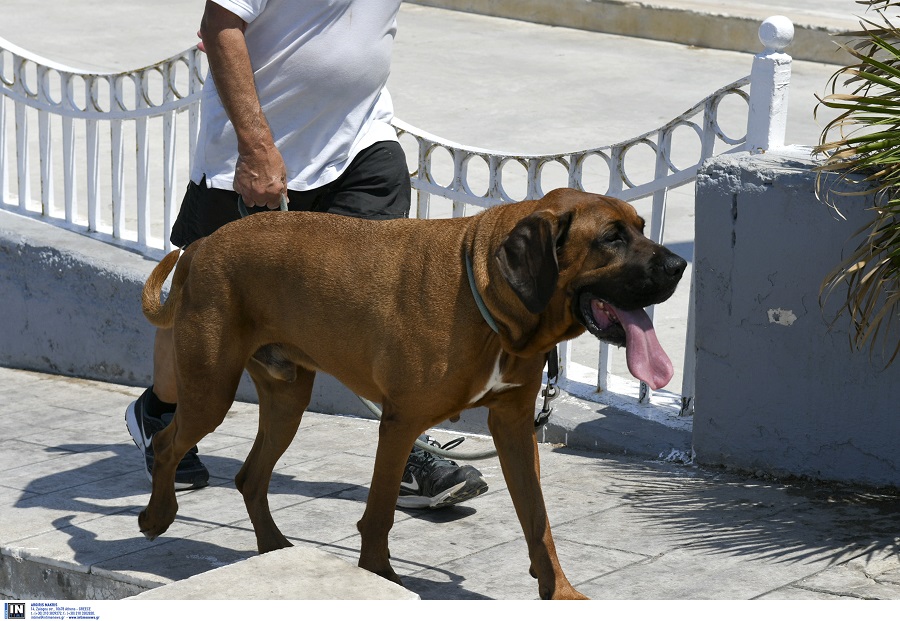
0,17,793,414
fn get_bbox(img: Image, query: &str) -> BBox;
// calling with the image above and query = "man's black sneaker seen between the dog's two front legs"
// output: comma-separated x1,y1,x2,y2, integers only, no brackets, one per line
397,436,487,509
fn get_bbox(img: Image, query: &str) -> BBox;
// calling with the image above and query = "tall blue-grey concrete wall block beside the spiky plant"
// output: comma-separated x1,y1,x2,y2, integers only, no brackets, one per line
693,152,900,486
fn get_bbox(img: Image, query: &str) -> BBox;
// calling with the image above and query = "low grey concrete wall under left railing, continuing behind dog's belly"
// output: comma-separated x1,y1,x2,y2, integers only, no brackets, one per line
0,210,370,417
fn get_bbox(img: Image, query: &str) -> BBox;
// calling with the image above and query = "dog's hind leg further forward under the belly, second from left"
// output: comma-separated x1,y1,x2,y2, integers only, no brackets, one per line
235,359,316,554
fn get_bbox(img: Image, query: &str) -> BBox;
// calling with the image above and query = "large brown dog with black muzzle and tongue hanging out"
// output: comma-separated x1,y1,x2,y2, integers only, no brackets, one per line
139,190,686,598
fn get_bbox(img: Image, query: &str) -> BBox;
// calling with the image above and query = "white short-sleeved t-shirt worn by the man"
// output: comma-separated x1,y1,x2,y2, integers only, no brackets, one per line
191,0,400,190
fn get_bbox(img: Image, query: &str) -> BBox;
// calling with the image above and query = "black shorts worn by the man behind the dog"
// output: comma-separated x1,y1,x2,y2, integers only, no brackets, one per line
170,140,411,248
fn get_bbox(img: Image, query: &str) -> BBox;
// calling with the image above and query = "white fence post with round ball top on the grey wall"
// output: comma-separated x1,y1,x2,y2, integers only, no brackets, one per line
746,15,794,152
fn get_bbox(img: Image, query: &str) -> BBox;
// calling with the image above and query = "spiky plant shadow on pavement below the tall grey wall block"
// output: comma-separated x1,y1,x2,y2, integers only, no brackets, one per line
560,449,900,565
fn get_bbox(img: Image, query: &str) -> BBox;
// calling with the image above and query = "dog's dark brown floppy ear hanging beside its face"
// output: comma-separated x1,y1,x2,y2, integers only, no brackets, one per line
494,211,572,313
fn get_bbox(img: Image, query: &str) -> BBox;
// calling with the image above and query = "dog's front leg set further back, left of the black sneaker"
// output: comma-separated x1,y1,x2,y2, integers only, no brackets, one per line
356,404,425,584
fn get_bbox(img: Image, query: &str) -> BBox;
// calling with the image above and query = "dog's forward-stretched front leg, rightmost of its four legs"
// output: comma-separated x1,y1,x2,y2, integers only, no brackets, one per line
488,391,585,599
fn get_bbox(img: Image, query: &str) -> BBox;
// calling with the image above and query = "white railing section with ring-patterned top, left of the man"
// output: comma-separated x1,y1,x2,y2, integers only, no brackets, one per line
0,39,206,257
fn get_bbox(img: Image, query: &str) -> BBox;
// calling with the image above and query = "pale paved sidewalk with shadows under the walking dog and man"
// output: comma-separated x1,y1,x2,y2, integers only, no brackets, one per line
0,368,900,600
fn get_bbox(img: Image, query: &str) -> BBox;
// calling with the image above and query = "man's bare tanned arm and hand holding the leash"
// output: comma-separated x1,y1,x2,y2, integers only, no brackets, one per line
199,0,287,209
